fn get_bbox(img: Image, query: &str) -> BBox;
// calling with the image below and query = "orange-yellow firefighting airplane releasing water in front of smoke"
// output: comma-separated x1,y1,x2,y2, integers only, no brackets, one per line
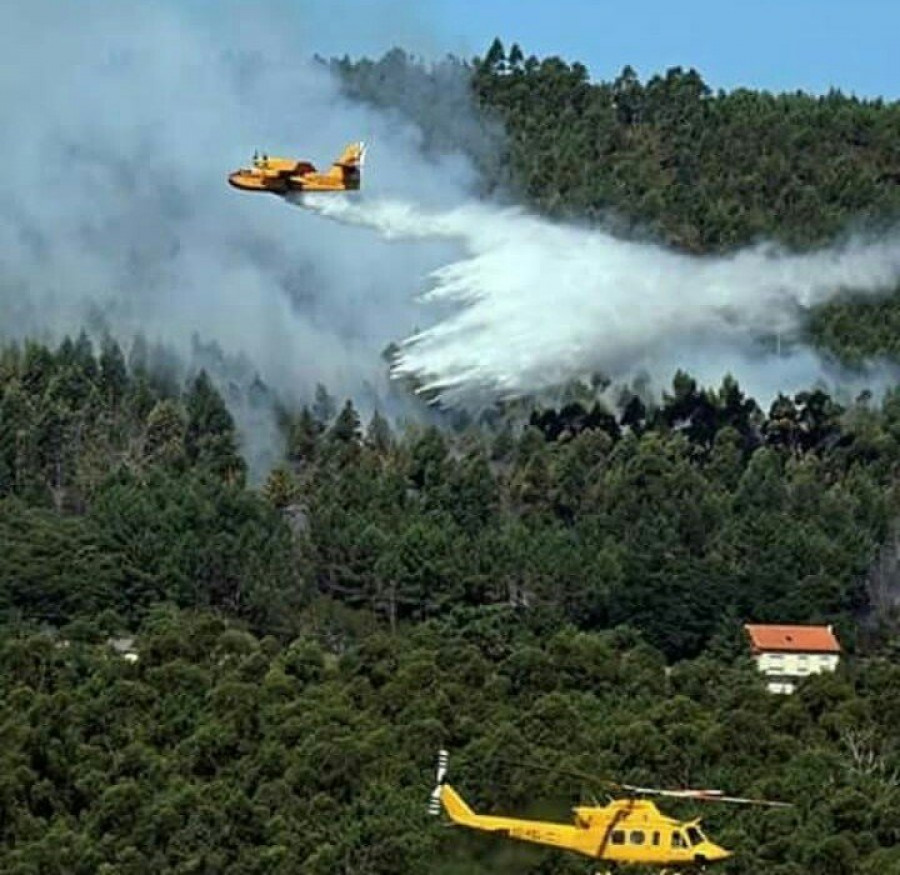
228,142,366,194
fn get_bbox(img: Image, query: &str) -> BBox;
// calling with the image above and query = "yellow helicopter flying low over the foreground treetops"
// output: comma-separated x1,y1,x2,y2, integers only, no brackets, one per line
429,750,790,875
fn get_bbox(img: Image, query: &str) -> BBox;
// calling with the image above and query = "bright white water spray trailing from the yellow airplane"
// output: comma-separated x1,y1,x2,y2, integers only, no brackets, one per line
302,196,900,400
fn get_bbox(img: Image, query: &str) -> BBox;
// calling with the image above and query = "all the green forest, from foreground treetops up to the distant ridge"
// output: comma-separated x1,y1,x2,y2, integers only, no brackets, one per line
0,45,900,875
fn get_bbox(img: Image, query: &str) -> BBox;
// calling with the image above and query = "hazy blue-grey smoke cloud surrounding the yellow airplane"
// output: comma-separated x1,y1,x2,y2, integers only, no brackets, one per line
0,0,488,476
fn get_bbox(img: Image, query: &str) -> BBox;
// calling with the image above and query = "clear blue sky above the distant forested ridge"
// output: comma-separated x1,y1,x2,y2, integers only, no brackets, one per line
282,0,900,100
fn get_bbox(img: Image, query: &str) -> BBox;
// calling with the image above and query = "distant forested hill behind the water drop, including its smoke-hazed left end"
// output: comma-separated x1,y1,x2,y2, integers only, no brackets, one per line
331,40,900,363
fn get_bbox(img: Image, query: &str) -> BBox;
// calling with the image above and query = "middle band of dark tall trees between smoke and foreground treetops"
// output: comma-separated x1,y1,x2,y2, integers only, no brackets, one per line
0,335,900,659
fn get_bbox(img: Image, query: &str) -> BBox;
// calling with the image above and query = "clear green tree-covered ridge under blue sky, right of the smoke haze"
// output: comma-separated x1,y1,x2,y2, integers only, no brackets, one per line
474,43,900,251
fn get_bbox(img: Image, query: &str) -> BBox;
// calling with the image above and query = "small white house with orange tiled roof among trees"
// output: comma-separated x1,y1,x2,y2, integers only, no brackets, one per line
744,624,841,693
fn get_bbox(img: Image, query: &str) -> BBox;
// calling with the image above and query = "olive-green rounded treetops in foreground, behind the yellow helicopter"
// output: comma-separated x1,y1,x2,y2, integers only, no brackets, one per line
0,606,900,875
